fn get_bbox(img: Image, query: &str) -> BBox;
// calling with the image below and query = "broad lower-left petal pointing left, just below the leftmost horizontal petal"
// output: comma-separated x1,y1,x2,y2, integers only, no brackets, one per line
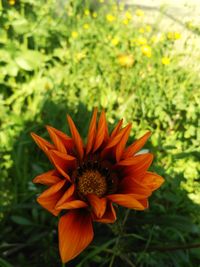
37,180,66,216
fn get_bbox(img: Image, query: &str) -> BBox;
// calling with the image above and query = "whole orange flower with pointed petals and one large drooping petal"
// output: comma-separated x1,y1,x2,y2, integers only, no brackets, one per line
31,108,164,263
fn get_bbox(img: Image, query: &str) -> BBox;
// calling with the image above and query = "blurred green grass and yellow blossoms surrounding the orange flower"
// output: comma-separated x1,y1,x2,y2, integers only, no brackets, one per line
0,0,200,267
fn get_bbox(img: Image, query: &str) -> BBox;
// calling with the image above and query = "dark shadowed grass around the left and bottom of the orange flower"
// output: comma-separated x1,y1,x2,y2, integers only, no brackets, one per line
1,97,200,267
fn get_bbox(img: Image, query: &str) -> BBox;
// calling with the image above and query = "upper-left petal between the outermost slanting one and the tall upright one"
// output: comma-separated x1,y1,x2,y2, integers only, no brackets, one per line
47,125,74,154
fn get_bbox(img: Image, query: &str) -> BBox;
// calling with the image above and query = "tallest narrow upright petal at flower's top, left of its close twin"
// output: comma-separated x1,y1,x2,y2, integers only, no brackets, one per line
86,108,97,155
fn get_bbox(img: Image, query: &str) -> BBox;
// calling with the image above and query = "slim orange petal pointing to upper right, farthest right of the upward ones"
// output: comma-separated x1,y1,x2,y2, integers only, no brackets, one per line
122,131,151,159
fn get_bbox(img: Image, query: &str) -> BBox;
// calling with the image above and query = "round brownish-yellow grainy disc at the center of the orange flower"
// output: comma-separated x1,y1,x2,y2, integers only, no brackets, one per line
77,169,108,197
